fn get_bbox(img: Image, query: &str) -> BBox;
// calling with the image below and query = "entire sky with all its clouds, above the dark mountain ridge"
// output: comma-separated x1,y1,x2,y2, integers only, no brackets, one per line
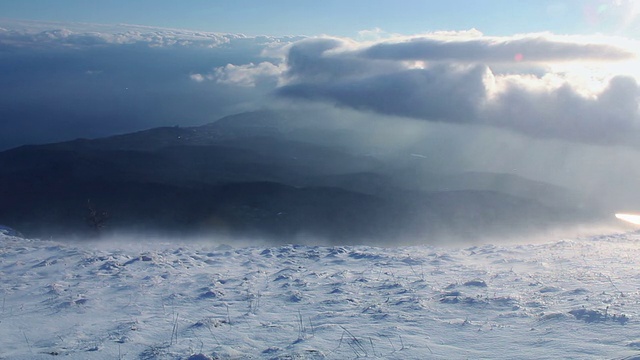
0,0,640,205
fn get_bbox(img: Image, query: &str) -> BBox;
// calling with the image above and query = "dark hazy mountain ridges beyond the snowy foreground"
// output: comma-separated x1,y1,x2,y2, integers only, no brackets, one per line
0,111,600,242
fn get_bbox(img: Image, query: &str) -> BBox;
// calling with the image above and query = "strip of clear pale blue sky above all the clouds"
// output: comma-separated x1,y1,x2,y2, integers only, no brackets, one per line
0,0,640,38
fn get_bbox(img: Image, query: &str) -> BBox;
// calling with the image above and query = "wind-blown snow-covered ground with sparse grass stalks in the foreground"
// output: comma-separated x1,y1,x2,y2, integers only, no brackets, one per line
0,233,640,359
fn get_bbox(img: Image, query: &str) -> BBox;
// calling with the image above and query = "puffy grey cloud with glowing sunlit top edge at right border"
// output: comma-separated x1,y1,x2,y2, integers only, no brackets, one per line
481,76,640,144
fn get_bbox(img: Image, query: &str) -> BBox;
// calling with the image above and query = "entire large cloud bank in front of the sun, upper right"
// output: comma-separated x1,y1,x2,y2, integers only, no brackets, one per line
264,35,640,144
